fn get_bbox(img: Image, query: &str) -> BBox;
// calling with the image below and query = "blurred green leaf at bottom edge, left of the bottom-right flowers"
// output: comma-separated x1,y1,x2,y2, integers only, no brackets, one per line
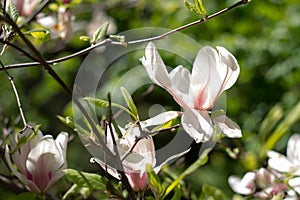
199,184,227,200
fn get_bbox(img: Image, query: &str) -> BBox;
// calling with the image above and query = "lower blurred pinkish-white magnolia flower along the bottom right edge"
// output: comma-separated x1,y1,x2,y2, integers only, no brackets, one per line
228,168,289,199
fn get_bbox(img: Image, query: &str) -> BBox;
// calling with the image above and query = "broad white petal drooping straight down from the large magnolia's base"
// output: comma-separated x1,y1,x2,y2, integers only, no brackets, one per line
181,109,213,143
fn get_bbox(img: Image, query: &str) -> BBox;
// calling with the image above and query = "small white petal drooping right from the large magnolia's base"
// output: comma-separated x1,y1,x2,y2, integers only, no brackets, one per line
213,115,242,138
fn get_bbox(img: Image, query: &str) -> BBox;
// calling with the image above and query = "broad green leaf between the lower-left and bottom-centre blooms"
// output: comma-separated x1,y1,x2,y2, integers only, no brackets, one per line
64,169,107,191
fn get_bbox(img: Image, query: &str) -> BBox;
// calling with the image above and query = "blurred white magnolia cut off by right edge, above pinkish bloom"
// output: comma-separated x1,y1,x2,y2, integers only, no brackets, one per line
268,134,300,176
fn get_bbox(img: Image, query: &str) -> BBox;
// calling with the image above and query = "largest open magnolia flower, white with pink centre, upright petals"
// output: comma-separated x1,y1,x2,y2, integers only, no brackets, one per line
141,42,241,143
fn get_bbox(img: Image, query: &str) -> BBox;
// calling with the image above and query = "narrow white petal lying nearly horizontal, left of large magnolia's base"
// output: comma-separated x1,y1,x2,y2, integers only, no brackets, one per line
140,111,181,127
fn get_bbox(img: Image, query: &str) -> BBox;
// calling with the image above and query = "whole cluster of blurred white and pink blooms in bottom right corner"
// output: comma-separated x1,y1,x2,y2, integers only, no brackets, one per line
228,134,300,200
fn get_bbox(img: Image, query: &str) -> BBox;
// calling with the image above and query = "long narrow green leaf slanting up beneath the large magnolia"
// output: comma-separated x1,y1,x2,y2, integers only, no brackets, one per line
164,147,212,197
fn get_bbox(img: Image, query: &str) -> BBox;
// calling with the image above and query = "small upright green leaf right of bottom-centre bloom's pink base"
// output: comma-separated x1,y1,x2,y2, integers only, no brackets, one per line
146,164,165,199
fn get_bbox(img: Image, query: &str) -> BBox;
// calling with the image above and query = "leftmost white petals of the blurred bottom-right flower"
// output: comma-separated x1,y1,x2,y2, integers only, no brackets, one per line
228,172,255,195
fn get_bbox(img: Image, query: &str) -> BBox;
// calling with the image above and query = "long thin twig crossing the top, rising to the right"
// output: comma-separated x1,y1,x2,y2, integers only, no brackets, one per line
0,0,248,71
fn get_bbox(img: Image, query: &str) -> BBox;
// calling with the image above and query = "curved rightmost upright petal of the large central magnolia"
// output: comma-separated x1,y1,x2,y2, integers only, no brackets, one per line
216,46,240,90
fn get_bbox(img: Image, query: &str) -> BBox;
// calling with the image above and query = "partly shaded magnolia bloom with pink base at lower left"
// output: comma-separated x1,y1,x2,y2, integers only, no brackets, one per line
5,129,68,193
